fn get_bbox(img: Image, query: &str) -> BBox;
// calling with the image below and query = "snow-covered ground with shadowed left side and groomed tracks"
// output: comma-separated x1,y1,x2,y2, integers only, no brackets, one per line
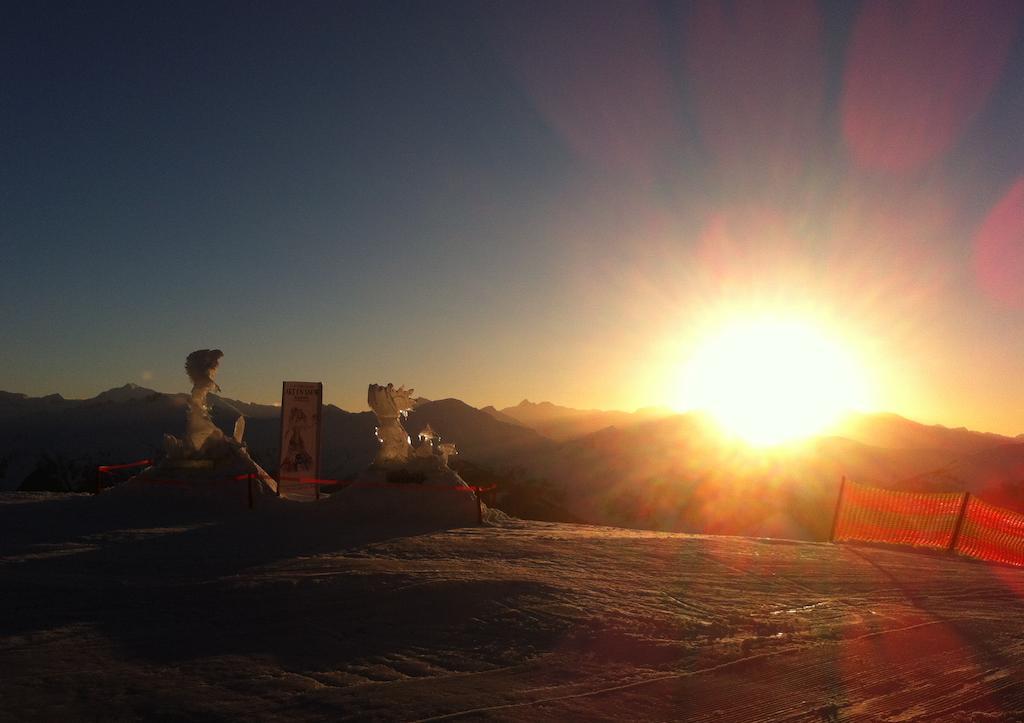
0,495,1024,721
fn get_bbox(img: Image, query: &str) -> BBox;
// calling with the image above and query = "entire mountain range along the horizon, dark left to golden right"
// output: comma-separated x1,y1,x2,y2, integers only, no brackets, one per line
0,384,1024,540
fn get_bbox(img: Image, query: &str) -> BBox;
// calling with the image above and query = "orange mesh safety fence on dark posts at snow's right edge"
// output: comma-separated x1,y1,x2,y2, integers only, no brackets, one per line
831,480,1024,565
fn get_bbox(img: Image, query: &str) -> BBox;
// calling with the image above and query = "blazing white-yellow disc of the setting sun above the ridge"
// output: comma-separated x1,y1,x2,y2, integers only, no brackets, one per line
685,317,865,445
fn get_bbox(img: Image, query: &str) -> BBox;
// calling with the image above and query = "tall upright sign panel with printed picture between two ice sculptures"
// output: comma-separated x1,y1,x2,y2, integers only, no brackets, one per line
278,382,324,500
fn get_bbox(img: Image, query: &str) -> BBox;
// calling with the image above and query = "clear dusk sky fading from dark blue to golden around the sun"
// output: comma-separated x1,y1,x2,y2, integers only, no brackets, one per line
0,0,1024,434
